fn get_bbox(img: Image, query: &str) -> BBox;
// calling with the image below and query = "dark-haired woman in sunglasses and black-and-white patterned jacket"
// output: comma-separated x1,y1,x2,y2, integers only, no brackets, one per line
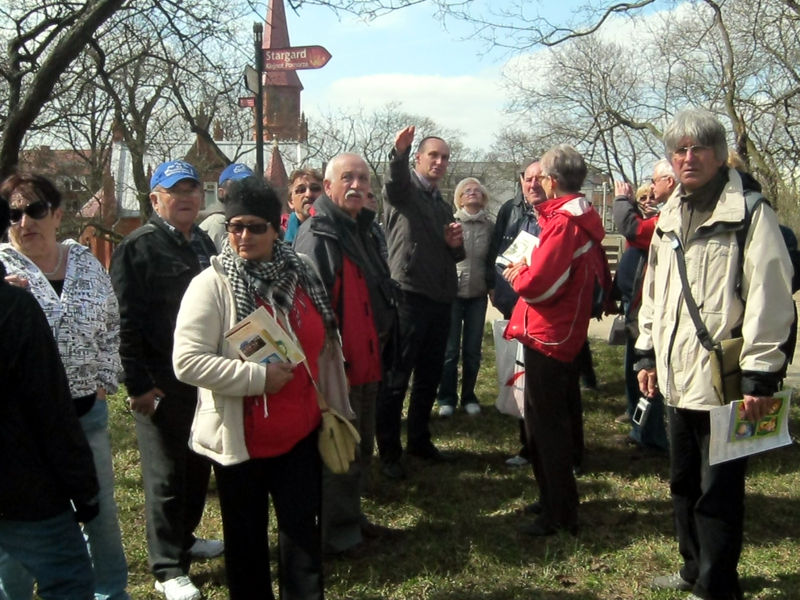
0,174,128,600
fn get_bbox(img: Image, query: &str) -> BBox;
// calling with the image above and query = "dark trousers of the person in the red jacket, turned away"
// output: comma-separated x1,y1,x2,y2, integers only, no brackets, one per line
525,347,583,529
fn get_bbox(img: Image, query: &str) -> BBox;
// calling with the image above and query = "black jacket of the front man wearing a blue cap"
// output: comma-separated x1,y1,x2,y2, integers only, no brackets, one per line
111,215,217,397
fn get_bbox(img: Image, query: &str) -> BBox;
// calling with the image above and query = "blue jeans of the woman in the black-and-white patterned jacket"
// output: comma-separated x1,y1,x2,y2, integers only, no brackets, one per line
0,400,130,600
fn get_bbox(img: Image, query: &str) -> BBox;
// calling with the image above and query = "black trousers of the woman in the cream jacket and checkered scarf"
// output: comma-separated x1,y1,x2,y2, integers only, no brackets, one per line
214,431,324,600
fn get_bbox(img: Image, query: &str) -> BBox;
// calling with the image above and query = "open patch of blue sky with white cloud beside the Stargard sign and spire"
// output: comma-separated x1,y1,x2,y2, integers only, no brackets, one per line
286,2,569,149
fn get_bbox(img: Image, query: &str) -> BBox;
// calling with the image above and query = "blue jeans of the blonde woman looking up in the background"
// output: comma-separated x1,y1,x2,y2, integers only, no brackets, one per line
439,296,487,406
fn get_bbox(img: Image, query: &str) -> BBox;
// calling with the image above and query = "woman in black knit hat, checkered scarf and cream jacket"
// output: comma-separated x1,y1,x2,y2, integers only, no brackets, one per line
173,177,336,600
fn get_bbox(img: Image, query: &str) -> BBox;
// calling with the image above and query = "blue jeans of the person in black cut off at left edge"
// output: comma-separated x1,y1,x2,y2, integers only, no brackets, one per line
0,510,94,600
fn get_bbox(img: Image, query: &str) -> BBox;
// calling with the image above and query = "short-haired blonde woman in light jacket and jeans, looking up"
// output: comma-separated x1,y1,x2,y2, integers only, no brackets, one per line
439,177,494,417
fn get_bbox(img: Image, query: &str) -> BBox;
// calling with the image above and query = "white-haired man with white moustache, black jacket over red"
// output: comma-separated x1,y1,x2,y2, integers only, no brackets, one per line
294,154,396,554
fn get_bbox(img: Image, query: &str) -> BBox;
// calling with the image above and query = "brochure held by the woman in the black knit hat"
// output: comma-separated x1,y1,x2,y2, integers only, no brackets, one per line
225,306,305,365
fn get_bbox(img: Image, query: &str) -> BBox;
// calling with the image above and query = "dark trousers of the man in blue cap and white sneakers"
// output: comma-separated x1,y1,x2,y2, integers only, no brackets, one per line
134,394,211,581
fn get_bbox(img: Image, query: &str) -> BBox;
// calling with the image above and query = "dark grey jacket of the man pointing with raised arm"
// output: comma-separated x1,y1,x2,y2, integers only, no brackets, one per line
384,148,466,303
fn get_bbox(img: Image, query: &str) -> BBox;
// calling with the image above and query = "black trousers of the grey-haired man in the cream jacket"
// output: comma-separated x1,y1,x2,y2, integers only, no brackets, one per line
667,407,747,600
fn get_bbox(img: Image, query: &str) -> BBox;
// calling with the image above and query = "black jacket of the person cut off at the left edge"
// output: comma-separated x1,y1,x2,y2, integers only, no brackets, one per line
0,265,98,521
